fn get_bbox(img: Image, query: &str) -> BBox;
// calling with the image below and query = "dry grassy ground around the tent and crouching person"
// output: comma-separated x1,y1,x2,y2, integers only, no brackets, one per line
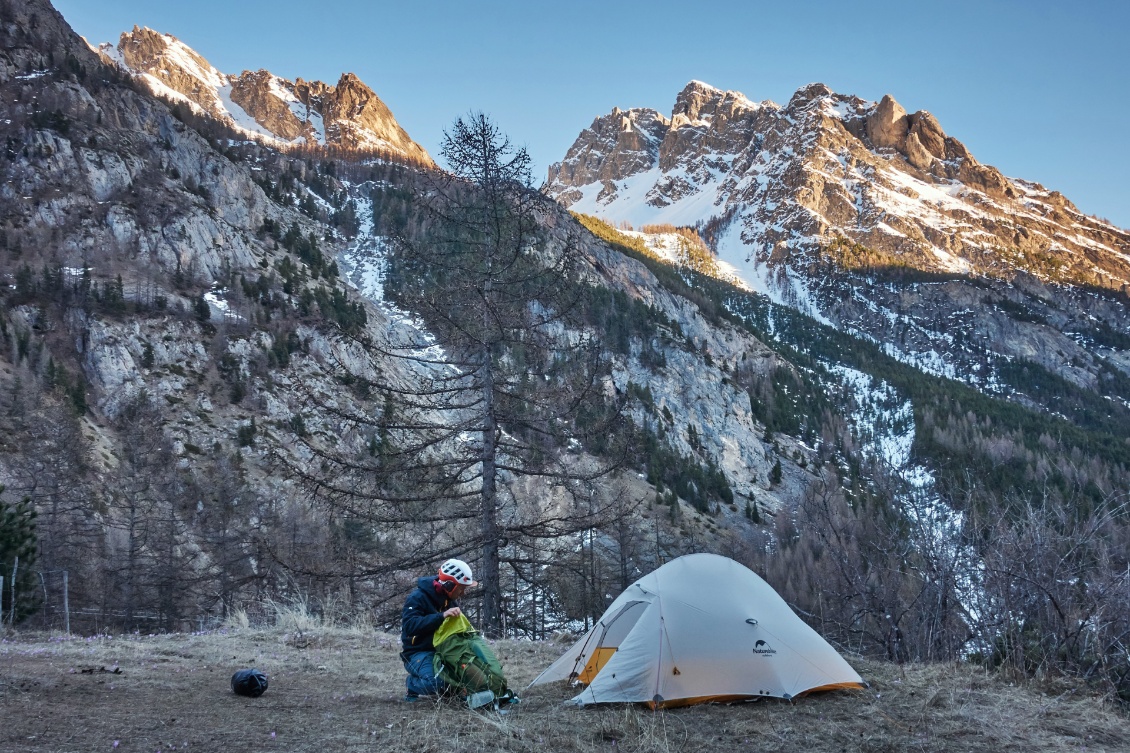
0,623,1130,753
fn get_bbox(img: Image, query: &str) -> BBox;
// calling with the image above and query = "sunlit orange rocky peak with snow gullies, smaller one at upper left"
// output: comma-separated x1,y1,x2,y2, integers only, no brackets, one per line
97,26,432,164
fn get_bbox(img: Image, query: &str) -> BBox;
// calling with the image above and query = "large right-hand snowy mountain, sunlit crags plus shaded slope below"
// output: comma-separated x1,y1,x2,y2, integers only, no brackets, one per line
547,81,1130,388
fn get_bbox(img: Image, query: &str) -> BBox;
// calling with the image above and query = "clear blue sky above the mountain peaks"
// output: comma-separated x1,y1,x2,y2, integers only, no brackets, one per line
54,0,1130,227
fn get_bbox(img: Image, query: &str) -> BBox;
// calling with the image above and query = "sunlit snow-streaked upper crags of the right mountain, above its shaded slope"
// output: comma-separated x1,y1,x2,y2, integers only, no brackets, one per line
548,81,1130,291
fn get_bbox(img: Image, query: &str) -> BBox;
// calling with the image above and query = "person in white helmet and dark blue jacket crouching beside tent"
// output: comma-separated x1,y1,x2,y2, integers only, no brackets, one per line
400,560,478,701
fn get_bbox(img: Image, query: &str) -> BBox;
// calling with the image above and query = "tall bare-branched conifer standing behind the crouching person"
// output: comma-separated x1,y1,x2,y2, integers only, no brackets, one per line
291,114,618,635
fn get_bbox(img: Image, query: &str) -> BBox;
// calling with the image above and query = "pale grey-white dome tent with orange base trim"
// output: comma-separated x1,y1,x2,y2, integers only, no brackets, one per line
530,554,863,708
